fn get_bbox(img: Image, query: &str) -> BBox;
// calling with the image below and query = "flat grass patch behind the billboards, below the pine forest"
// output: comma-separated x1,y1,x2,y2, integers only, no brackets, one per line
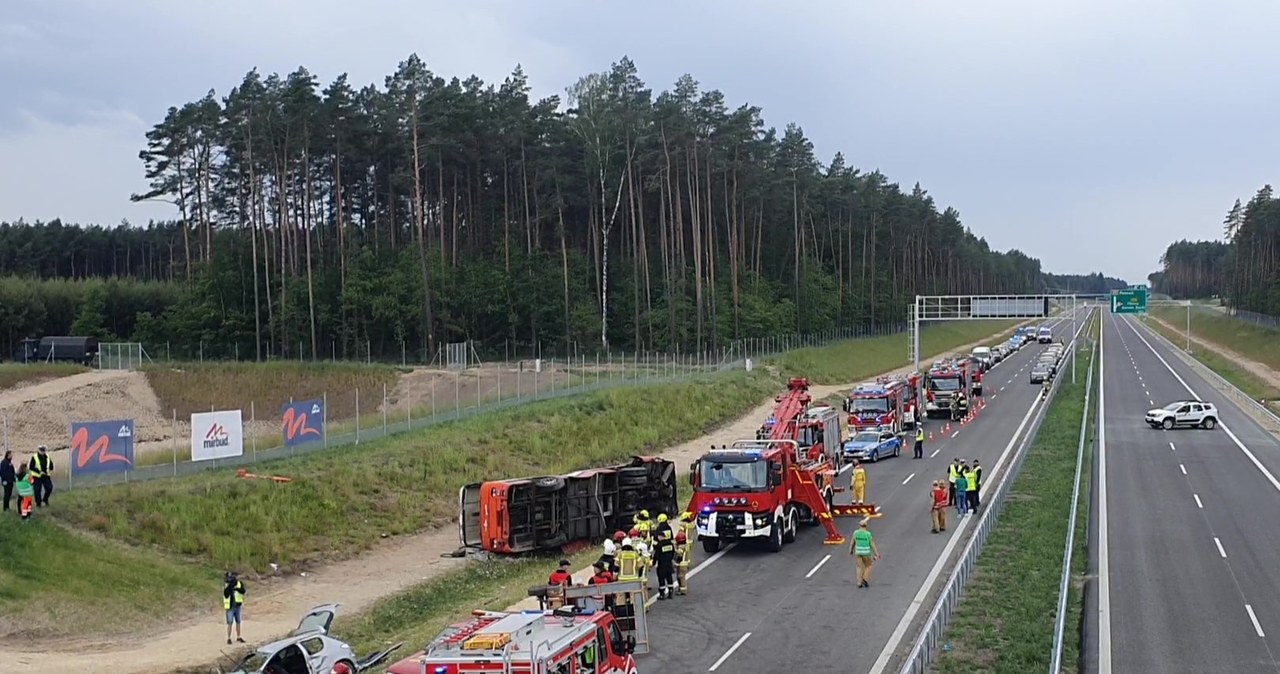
143,361,403,419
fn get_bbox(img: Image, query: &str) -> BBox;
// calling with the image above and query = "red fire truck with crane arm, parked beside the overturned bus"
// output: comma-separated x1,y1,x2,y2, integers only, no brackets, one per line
687,377,878,553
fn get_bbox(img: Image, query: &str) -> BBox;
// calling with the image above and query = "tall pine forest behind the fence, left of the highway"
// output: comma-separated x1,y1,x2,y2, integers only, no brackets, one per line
0,55,1044,358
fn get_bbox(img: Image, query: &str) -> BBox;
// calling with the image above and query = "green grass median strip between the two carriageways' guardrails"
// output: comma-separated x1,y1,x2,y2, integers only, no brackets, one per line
932,317,1097,674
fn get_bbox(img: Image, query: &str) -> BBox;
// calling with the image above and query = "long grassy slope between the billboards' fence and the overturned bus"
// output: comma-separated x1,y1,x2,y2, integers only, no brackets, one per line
50,372,778,576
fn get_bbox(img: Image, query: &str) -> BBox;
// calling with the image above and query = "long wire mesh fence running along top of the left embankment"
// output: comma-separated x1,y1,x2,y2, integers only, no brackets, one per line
0,324,906,489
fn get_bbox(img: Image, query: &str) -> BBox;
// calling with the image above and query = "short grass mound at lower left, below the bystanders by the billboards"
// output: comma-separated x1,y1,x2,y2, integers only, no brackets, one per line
0,514,219,641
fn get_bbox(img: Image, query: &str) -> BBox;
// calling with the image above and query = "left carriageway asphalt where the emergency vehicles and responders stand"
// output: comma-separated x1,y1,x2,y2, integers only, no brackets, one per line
641,308,1083,674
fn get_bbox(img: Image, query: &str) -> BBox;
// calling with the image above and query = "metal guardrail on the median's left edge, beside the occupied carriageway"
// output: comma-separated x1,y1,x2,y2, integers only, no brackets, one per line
899,313,1093,674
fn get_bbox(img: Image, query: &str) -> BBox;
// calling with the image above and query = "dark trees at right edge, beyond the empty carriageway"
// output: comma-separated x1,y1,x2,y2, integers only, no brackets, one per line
1149,185,1280,316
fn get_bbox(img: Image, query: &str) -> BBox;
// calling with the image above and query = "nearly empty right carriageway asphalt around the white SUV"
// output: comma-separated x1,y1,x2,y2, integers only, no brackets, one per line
1084,313,1280,674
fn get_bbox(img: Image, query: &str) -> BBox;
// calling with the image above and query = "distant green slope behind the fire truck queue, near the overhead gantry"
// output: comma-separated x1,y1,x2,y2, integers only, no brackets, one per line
777,320,1021,384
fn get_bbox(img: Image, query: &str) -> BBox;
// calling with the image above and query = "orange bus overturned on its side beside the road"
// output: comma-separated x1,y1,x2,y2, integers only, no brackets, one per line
458,457,677,554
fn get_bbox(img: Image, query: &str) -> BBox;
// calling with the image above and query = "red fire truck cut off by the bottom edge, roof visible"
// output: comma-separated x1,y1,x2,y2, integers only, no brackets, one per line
387,581,649,674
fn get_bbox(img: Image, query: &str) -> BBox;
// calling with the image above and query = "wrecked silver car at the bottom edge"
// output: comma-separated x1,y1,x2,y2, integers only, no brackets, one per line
228,604,402,674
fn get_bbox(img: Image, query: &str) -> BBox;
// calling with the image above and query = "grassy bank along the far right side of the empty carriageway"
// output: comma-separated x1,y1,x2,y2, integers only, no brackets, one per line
1147,307,1280,413
